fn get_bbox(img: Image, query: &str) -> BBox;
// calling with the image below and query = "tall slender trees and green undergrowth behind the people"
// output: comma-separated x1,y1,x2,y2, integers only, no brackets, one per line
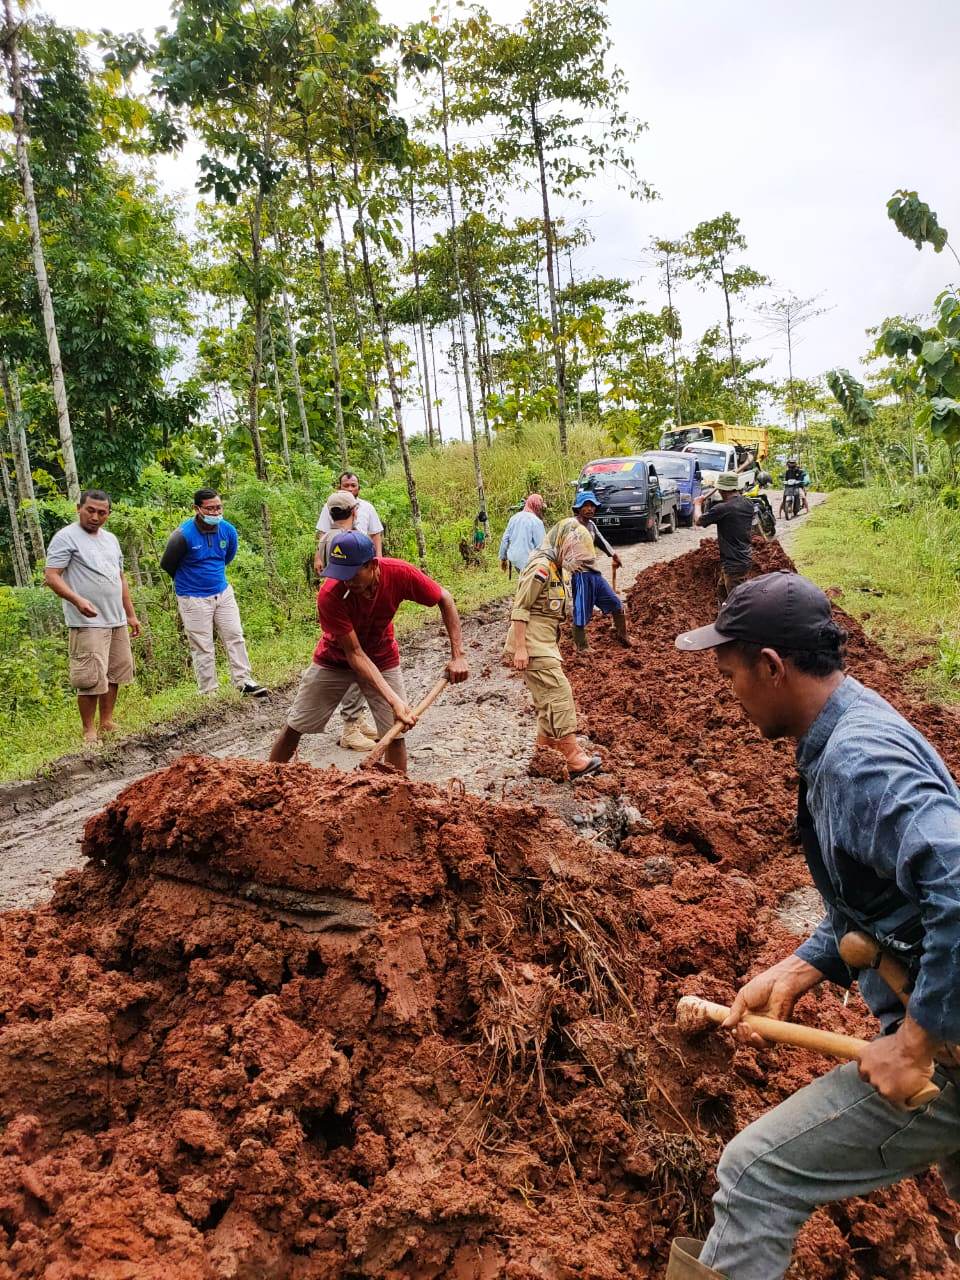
0,0,960,774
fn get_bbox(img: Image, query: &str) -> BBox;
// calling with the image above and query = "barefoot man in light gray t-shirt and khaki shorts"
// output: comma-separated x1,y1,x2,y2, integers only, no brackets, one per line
44,489,140,742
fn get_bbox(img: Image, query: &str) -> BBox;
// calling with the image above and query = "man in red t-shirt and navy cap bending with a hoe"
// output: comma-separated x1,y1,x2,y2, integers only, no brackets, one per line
270,529,470,773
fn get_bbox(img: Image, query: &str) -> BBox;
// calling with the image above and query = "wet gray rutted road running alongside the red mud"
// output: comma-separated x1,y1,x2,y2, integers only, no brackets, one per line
0,495,823,910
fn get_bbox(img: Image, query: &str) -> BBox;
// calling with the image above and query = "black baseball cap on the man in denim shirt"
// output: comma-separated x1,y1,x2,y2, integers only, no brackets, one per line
675,571,836,652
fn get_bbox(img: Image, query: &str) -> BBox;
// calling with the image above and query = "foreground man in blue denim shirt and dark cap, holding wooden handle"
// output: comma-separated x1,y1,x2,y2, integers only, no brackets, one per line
667,573,960,1280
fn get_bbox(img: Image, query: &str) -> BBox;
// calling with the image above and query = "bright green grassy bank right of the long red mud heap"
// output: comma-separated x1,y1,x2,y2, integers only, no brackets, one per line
791,488,960,701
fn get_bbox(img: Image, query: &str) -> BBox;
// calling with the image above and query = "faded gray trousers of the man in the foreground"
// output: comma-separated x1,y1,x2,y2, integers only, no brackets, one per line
700,1062,960,1280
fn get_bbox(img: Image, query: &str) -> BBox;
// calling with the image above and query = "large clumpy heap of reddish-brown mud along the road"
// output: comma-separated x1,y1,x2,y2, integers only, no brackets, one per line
0,547,960,1280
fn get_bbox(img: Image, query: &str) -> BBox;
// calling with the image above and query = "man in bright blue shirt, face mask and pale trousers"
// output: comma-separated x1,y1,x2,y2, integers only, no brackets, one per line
160,489,266,698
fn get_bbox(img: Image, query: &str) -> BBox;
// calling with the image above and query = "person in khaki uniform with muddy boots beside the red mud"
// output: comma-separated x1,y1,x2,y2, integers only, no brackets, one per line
503,517,602,778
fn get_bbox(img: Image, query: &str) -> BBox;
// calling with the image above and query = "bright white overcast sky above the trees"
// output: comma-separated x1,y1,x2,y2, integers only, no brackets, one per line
40,0,960,430
